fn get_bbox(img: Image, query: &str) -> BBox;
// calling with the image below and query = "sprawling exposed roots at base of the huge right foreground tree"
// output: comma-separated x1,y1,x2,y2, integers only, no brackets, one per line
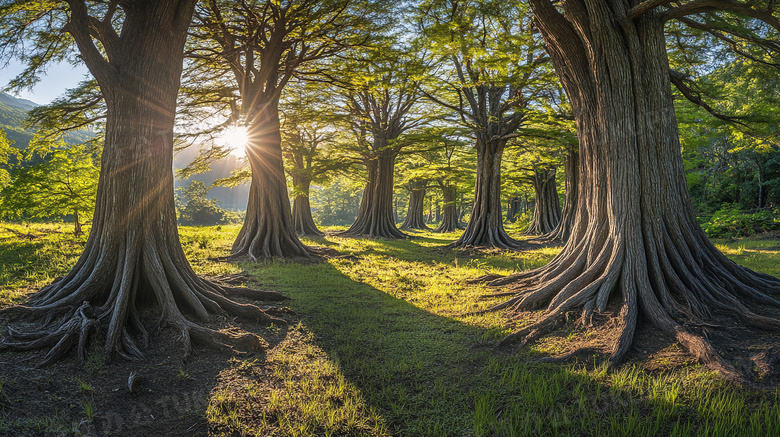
478,225,780,382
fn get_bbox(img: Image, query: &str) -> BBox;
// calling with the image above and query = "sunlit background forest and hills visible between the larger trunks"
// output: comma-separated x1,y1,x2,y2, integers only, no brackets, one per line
0,3,780,237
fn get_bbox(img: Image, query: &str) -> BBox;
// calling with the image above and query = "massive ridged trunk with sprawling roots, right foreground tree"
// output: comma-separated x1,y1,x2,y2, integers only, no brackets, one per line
493,0,780,378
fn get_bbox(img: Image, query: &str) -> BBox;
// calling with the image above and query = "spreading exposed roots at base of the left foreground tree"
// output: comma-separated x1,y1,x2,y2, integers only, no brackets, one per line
0,240,286,365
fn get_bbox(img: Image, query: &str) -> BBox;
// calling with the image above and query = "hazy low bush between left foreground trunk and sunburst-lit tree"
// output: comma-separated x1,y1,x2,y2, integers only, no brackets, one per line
178,181,241,225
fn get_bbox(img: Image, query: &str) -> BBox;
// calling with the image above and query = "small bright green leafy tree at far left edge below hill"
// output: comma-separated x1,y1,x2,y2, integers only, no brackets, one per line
0,144,100,236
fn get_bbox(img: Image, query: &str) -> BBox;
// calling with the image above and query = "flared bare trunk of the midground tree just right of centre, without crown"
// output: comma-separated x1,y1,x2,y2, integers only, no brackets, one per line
450,138,520,249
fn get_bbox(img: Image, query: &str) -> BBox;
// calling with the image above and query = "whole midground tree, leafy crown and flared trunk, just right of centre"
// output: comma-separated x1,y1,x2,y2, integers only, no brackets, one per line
419,0,553,249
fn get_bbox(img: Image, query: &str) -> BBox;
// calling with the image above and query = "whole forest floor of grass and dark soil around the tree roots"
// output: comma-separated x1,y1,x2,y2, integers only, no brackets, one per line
0,223,780,436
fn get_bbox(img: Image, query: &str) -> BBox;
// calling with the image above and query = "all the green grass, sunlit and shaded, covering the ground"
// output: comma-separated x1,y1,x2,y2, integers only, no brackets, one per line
0,225,780,436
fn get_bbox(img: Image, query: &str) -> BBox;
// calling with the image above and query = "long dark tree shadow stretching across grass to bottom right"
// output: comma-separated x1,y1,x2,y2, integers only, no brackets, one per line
238,258,780,436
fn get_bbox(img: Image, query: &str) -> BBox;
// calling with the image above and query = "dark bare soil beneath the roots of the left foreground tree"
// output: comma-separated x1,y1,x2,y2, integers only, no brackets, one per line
0,302,292,436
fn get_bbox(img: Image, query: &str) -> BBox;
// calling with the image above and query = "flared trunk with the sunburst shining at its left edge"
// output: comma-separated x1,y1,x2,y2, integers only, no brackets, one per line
231,99,314,261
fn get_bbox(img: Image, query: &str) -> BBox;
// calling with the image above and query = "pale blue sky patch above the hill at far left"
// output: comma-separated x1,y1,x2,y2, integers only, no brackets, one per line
0,61,89,105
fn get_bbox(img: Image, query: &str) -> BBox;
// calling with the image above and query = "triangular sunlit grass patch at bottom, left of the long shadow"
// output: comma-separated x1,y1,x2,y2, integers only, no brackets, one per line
206,325,388,437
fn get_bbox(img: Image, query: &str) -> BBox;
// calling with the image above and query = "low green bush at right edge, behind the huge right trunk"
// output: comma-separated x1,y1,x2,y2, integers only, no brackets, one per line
701,204,780,238
